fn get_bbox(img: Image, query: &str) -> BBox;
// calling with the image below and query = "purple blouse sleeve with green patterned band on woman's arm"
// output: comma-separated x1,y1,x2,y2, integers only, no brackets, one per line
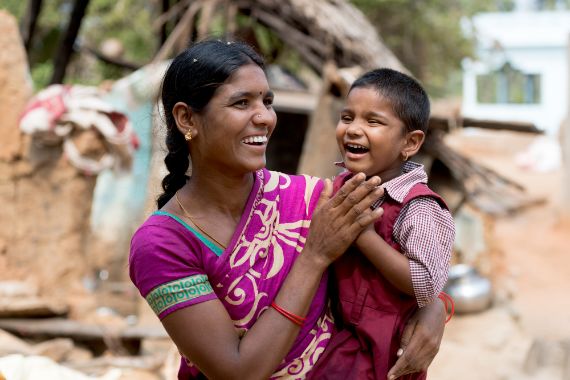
129,223,217,320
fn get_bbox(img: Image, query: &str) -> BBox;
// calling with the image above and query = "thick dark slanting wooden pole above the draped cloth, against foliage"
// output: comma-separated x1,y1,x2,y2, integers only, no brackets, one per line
50,0,89,84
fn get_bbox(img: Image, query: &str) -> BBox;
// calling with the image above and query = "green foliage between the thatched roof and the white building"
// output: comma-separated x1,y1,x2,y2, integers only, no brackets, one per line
352,0,511,97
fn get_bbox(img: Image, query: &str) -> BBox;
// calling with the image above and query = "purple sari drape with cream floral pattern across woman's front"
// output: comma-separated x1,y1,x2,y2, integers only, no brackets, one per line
210,170,332,379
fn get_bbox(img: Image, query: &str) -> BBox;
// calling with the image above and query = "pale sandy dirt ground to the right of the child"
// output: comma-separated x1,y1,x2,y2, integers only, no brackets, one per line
429,128,570,380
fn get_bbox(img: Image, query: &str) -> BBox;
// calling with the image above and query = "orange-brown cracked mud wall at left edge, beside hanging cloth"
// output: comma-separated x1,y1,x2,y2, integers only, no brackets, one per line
0,11,103,295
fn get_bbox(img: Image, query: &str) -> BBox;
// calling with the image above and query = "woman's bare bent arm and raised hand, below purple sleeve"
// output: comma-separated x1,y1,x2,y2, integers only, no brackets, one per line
162,175,381,379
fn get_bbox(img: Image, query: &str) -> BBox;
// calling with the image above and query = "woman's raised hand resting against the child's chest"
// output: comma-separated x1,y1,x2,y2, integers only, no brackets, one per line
303,173,383,265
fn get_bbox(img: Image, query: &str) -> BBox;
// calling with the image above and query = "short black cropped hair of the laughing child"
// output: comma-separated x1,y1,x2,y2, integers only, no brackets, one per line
349,68,430,133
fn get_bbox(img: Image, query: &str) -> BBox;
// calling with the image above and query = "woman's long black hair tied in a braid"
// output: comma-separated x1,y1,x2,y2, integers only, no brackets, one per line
156,40,265,208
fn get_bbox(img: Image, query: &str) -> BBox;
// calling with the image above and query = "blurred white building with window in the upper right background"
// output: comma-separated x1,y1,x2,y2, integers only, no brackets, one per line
462,0,570,134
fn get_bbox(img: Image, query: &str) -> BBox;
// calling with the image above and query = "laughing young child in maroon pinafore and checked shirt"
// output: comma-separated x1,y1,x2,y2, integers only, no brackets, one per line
311,69,455,380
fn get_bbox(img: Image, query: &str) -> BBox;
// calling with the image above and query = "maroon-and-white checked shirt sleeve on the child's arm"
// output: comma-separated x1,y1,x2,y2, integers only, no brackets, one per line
394,197,455,307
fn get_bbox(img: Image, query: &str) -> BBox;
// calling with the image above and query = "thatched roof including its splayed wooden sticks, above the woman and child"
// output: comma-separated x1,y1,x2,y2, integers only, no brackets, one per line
154,0,407,74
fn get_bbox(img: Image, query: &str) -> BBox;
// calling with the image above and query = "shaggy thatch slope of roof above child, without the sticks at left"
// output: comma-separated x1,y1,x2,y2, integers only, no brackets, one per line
238,0,405,72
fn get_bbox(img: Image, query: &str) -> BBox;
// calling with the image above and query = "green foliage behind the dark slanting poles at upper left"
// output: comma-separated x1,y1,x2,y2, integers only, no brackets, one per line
0,0,158,88
